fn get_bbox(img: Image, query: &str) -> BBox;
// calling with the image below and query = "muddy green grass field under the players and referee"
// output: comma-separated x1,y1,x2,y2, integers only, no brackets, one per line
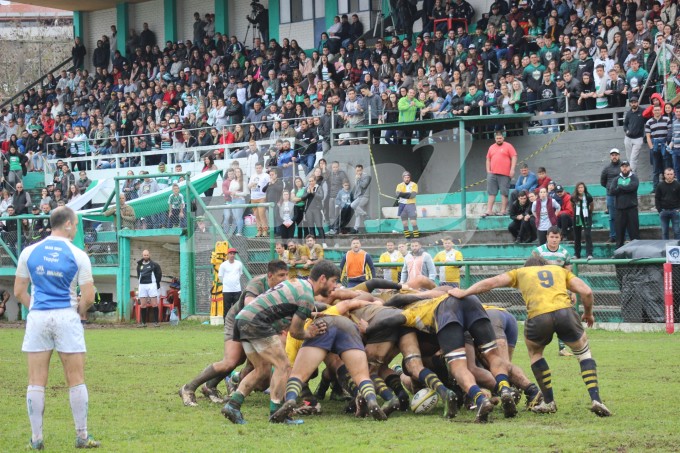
0,323,680,452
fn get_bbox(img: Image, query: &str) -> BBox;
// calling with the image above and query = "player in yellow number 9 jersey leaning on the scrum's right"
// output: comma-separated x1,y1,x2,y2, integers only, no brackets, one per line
450,256,611,417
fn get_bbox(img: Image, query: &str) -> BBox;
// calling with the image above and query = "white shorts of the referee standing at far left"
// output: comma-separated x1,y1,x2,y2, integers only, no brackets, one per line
21,308,86,353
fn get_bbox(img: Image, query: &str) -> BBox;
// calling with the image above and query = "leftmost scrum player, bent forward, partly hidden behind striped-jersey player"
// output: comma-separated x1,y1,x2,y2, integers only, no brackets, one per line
179,260,288,407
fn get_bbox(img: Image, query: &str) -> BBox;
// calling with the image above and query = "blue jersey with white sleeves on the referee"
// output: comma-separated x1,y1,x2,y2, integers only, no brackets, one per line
16,236,93,310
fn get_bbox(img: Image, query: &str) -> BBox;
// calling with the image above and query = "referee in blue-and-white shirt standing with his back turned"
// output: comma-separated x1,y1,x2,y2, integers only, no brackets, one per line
14,207,99,450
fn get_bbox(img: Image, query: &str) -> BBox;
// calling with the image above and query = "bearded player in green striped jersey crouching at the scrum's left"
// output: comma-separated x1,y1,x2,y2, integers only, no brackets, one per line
222,260,340,424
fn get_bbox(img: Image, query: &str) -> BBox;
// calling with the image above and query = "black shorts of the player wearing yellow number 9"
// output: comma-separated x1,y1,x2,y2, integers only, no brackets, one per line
524,308,584,346
